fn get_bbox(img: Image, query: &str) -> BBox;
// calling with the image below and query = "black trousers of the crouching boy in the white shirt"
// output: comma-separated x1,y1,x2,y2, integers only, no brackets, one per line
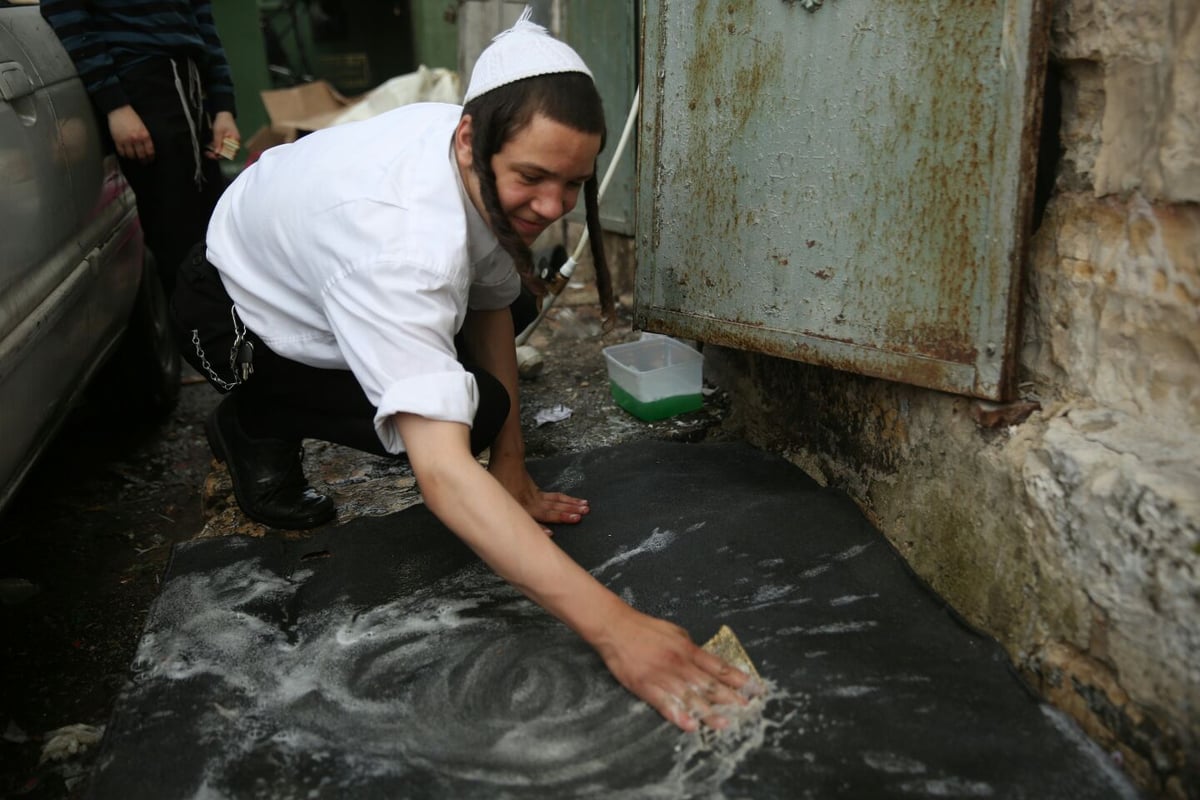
172,245,528,456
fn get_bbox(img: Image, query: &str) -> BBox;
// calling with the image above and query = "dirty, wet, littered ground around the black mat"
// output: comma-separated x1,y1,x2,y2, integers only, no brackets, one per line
0,284,731,800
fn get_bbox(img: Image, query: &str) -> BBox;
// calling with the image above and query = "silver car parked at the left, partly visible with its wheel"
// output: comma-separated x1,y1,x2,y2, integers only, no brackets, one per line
0,0,180,511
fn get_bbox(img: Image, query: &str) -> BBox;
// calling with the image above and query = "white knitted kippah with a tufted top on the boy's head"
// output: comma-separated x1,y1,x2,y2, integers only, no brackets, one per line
462,6,593,104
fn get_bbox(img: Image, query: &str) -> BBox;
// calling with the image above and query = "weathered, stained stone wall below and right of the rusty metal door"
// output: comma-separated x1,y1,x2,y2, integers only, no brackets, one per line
706,0,1200,798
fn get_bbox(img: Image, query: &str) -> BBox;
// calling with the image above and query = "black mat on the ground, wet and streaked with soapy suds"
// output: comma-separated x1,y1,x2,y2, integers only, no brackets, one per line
90,441,1136,800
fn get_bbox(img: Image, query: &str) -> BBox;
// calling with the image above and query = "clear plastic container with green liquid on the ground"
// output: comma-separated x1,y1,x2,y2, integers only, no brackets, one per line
604,336,704,422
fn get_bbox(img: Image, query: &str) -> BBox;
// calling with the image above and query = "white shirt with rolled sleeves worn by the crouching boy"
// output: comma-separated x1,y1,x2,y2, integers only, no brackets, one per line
208,103,521,453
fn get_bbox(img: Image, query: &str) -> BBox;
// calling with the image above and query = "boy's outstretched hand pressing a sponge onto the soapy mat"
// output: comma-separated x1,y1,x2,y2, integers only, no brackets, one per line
594,607,750,732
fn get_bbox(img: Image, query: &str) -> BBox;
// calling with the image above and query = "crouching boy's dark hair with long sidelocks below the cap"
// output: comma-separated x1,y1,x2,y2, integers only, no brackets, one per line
463,72,616,324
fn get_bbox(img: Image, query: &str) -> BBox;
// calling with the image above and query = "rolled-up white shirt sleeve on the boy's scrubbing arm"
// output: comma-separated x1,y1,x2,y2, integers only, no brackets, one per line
324,263,479,453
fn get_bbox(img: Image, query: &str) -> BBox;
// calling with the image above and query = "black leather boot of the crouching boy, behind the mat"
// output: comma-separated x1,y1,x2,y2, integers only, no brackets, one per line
204,396,337,530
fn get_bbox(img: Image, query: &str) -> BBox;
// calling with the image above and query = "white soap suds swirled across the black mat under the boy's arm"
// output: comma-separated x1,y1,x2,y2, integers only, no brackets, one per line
138,563,767,798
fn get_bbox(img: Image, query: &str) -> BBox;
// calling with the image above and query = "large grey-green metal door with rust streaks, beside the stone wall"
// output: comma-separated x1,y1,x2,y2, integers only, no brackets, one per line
635,0,1048,399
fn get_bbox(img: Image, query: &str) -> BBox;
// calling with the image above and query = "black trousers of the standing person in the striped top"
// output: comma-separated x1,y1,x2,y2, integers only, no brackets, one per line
117,59,228,297
